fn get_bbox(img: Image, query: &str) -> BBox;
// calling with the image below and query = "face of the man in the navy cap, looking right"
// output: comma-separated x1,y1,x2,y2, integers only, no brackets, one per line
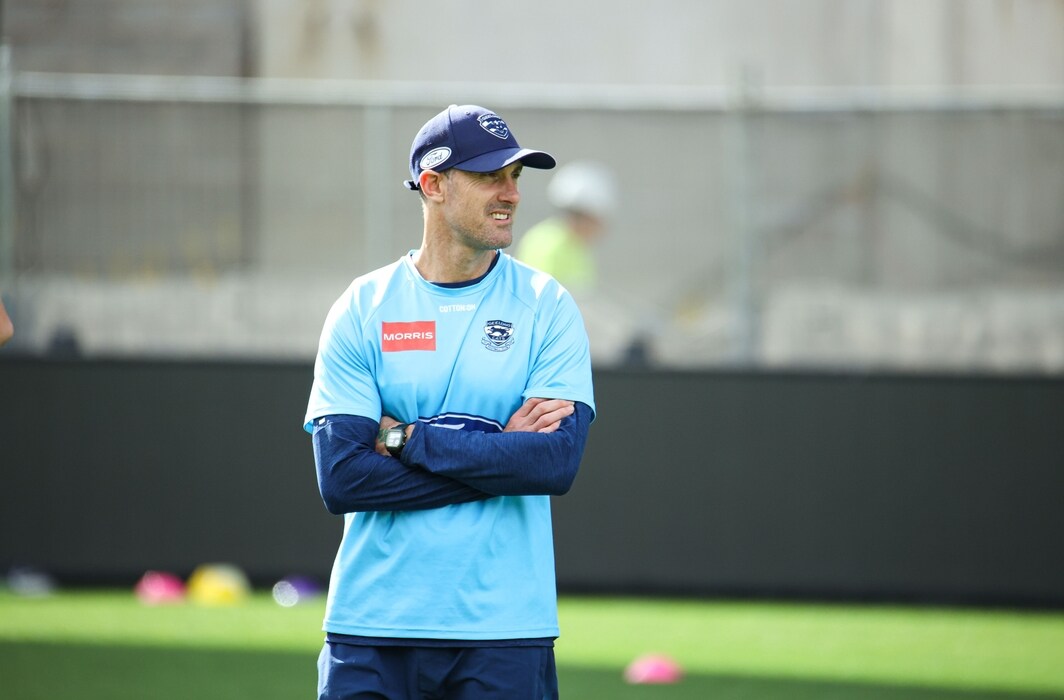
444,163,523,250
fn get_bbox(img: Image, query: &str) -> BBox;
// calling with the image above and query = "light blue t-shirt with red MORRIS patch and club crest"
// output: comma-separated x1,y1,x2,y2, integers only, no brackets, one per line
304,252,595,639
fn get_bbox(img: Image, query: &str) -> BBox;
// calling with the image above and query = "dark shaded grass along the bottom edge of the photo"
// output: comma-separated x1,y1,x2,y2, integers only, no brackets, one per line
0,641,1064,700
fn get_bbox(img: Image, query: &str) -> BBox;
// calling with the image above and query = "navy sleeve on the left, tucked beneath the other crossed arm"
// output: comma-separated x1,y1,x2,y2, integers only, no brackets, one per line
313,415,491,515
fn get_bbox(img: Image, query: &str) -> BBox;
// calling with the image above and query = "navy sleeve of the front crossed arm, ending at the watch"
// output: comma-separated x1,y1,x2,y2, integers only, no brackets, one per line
402,402,593,496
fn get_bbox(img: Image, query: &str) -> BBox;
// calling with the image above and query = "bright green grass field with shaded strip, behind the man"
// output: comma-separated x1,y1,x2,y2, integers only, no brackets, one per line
0,590,1064,700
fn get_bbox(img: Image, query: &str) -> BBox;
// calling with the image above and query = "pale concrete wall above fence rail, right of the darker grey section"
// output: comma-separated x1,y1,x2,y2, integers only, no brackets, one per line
256,0,1064,86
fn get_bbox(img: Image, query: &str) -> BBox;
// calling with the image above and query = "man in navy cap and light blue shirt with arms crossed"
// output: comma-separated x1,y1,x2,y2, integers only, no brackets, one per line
304,105,595,700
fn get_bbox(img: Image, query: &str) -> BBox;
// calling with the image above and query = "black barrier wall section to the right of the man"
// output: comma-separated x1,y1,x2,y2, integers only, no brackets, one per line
554,372,1064,605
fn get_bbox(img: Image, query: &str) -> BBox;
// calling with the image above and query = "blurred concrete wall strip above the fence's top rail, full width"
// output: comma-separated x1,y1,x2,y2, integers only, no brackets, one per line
8,0,1064,86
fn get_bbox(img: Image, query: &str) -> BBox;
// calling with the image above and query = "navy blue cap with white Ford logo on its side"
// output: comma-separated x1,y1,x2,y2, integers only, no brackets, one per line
403,104,556,189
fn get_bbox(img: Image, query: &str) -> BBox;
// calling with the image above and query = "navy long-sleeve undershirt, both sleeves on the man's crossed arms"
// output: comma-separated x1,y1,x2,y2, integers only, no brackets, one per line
314,402,593,514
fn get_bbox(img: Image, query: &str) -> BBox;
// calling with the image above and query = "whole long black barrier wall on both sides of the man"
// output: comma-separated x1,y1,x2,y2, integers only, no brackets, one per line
0,357,1064,605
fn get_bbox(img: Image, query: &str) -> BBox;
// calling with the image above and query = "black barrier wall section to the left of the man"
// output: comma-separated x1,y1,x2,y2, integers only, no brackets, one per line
0,359,343,582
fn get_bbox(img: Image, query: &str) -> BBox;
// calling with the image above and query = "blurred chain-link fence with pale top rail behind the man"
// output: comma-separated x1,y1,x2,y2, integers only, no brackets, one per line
0,73,1064,373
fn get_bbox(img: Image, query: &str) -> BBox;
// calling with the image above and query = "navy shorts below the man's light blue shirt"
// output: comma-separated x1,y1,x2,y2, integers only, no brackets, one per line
318,641,558,700
